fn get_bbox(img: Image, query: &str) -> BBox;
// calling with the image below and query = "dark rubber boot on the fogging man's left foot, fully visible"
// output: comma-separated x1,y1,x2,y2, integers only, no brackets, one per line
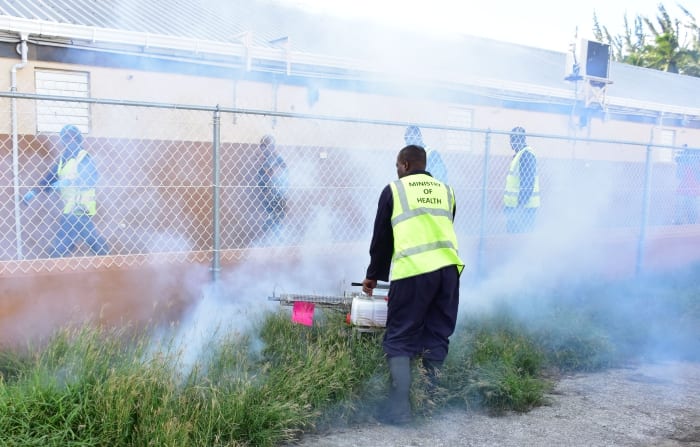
378,357,413,425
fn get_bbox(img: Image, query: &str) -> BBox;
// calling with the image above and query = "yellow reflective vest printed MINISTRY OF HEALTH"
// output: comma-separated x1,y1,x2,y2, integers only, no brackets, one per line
390,174,464,280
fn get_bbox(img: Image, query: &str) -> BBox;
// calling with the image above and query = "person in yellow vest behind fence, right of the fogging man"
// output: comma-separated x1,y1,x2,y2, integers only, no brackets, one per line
503,126,540,233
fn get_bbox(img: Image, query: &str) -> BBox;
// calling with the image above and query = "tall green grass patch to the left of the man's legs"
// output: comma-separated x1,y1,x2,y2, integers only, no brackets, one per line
0,312,382,446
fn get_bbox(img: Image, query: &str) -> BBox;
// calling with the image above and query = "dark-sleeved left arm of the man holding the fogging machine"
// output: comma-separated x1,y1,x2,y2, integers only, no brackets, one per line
365,185,394,281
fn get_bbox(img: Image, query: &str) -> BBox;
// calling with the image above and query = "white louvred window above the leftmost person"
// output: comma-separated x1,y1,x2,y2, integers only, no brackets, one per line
35,69,90,133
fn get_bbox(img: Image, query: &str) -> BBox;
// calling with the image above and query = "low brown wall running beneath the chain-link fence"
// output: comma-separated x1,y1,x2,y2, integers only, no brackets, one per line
5,225,700,347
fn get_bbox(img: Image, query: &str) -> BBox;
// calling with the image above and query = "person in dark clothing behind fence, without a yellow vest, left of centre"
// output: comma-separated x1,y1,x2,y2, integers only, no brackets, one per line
257,135,289,240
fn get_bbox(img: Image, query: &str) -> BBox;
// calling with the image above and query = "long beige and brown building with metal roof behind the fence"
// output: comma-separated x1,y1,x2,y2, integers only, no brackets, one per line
0,0,700,346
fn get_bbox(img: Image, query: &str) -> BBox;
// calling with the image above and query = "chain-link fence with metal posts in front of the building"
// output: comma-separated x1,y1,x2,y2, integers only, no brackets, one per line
0,93,692,272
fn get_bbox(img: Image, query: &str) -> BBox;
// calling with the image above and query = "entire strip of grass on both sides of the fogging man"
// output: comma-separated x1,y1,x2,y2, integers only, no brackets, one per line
0,272,700,447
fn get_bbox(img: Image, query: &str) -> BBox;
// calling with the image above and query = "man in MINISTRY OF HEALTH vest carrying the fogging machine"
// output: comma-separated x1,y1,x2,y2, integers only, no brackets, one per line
362,145,464,425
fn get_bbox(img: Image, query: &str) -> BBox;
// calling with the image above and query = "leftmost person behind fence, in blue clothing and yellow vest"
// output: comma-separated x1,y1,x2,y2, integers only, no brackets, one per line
22,124,109,258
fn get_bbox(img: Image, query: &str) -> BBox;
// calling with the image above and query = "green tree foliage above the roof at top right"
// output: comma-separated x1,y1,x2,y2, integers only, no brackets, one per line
593,4,700,77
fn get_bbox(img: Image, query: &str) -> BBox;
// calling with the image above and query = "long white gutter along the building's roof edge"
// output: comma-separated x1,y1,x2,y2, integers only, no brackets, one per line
0,14,700,121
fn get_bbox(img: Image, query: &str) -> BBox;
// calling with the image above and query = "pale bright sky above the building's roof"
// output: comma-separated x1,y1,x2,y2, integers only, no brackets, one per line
277,0,700,52
